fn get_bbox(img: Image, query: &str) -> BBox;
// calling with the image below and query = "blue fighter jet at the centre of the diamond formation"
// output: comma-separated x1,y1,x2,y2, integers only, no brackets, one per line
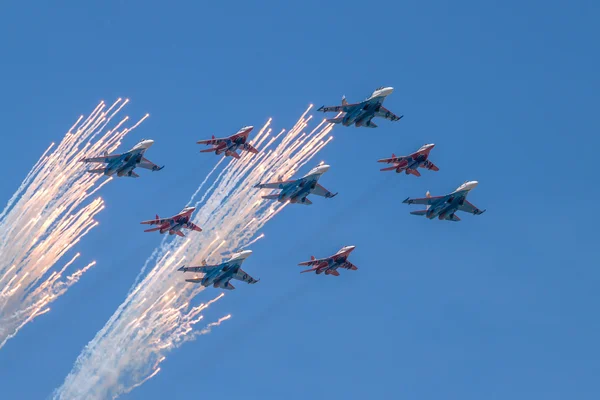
254,165,337,205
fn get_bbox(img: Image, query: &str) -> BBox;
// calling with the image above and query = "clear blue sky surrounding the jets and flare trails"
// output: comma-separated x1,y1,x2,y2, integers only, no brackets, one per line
0,0,600,400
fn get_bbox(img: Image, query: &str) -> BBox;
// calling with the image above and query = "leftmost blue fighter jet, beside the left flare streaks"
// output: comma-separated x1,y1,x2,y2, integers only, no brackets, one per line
79,139,164,178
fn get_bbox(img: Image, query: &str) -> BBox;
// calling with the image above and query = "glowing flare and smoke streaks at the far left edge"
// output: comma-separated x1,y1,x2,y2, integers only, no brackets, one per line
0,99,146,348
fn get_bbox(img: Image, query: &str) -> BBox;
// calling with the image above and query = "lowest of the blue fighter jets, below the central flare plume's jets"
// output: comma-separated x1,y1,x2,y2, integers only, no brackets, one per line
178,250,260,290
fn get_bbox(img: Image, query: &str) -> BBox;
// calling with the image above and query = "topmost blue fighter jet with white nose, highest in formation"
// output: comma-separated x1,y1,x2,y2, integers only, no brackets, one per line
317,87,403,128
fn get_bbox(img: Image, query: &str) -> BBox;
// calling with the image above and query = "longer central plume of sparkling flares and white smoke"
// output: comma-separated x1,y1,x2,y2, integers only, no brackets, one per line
54,105,333,399
